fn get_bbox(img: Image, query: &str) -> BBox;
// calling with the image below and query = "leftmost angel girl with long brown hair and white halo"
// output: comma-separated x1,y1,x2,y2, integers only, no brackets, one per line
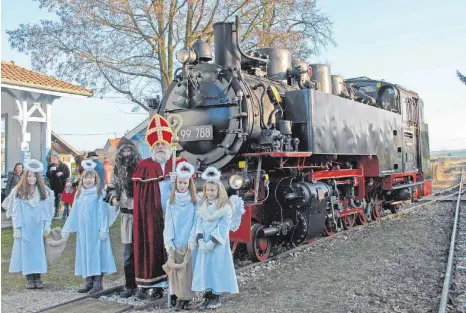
9,160,55,289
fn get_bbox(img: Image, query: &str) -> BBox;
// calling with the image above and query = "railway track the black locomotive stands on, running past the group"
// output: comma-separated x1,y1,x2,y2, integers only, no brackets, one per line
36,175,466,313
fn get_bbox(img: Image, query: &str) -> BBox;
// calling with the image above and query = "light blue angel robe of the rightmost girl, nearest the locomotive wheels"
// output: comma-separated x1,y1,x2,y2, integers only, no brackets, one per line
192,203,238,294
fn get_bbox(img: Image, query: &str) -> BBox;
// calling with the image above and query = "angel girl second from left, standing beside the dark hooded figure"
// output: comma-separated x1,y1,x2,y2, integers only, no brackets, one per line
62,160,117,294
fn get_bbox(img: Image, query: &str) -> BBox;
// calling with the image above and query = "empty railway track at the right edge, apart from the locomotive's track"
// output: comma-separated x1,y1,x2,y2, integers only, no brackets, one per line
439,167,466,313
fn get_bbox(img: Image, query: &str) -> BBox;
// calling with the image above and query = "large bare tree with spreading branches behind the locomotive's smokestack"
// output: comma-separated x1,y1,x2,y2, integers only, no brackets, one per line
7,0,334,110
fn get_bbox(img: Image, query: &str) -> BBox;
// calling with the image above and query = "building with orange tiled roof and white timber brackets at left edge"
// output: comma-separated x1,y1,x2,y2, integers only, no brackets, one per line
1,61,93,196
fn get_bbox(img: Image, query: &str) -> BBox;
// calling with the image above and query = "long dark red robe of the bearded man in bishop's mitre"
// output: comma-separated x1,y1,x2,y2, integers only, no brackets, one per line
133,158,186,286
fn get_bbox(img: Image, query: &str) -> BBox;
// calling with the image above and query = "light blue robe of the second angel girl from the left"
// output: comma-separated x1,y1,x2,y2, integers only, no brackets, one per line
62,187,116,277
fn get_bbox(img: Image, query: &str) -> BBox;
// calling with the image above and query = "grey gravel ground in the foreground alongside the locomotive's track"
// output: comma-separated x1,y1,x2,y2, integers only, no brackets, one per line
2,203,454,313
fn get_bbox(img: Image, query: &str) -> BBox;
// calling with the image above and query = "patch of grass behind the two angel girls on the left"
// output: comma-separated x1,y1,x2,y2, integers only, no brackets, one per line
1,218,124,294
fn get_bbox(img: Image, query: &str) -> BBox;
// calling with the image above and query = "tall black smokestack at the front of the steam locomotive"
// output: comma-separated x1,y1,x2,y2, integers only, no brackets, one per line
214,22,241,68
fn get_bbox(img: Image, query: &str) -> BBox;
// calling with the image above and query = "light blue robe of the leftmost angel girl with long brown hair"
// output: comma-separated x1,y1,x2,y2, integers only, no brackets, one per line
9,189,54,275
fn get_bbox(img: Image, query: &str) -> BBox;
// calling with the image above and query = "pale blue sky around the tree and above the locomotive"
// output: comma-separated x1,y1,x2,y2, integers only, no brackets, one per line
1,0,466,150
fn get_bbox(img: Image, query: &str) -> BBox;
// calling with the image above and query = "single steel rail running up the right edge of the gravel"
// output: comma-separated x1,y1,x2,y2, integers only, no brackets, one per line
439,167,464,313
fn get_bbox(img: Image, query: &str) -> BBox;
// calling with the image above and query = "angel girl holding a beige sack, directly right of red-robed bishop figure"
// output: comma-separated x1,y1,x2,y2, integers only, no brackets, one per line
163,162,199,311
